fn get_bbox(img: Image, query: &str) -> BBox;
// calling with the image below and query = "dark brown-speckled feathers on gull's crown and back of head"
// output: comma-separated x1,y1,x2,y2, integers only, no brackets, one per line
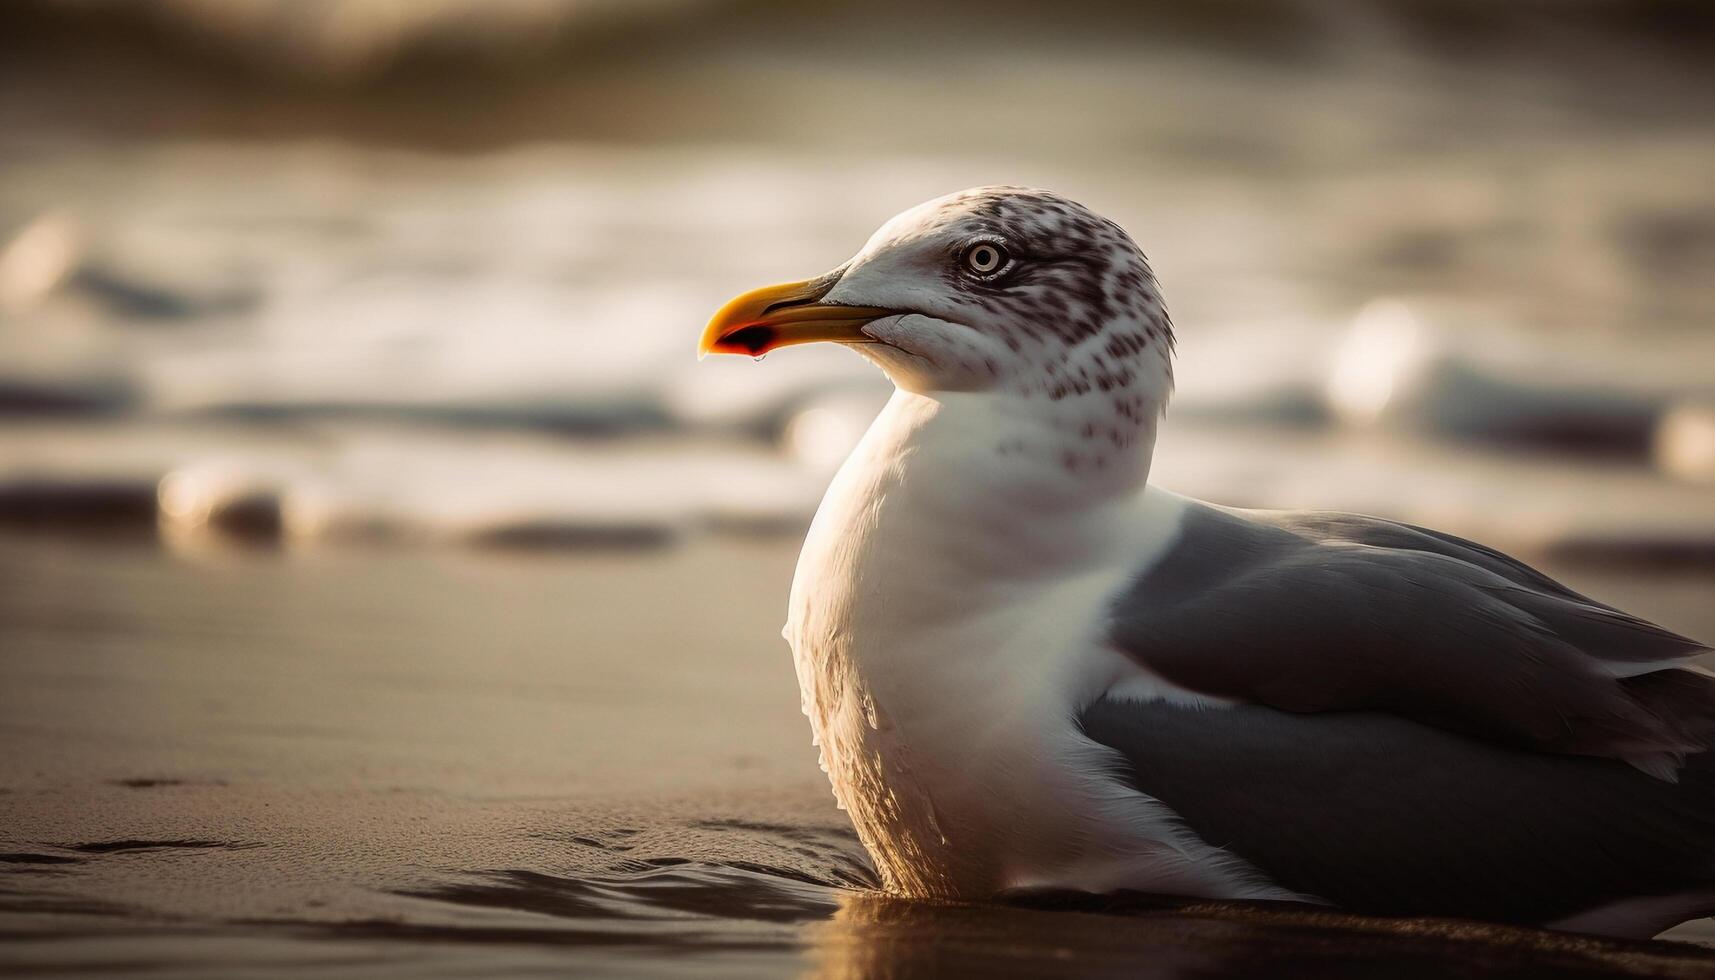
943,187,1173,403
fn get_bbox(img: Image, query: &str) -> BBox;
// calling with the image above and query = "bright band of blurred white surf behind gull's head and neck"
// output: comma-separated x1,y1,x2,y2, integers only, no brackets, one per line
0,146,1715,561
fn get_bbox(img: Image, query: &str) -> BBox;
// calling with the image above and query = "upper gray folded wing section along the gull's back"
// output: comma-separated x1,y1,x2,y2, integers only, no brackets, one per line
1110,503,1715,777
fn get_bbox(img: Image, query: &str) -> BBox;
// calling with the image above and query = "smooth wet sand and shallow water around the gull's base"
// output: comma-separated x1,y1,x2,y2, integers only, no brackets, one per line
10,535,1715,977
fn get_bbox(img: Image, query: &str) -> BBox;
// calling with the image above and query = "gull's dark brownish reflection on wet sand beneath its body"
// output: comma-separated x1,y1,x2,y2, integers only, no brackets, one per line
808,892,1715,980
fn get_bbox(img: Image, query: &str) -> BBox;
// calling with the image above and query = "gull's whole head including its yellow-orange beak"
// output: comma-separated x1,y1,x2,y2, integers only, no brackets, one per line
700,187,1173,414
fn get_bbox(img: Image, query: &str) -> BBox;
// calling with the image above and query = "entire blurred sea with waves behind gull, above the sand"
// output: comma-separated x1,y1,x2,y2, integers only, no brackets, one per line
0,0,1715,561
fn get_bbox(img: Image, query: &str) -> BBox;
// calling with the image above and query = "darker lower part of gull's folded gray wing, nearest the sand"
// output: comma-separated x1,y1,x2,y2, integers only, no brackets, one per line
1080,699,1715,929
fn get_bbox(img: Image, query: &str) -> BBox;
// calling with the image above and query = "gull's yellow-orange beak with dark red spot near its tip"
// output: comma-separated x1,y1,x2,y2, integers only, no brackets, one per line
696,276,899,360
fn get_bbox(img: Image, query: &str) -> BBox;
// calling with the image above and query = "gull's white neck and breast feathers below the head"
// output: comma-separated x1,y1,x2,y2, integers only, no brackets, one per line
785,391,1303,899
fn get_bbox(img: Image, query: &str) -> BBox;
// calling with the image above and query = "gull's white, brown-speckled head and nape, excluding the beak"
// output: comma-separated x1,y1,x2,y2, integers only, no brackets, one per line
792,187,1173,487
